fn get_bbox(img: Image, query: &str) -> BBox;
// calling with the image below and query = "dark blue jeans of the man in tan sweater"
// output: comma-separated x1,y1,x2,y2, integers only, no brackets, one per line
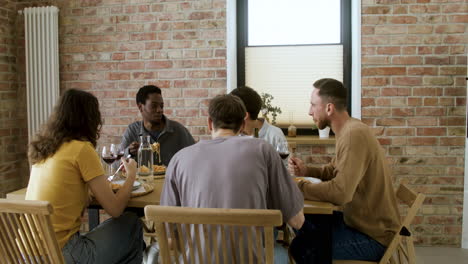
290,212,386,264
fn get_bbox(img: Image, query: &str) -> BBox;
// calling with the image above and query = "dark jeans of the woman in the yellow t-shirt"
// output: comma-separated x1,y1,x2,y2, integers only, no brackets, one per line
62,212,145,264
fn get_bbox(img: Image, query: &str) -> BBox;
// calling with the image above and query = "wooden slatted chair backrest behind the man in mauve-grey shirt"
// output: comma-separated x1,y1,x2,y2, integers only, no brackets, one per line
145,205,282,264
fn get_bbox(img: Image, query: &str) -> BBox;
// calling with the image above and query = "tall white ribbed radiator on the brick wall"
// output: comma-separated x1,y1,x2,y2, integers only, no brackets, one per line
24,6,59,141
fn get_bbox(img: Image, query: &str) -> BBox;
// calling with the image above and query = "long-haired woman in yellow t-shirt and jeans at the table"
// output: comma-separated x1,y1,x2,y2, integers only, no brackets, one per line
26,89,144,263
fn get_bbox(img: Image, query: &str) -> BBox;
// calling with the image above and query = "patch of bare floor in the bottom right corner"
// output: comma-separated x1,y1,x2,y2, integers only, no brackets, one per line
416,247,468,264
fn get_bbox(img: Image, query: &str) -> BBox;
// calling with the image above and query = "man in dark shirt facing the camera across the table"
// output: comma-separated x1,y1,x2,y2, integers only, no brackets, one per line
121,85,195,166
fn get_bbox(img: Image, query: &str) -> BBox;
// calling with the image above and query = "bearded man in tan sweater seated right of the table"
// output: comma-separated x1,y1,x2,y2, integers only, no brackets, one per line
289,79,400,263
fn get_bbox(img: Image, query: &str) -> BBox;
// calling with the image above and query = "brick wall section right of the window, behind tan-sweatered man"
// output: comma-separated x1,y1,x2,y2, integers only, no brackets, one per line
361,0,468,246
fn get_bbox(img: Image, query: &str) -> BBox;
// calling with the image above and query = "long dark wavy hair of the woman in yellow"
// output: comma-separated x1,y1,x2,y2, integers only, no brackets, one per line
28,89,102,164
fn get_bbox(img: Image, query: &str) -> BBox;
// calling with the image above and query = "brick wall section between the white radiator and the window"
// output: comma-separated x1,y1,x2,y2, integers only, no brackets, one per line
52,0,226,144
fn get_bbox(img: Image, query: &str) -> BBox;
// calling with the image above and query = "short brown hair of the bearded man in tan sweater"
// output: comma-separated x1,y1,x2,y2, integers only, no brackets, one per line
314,78,348,111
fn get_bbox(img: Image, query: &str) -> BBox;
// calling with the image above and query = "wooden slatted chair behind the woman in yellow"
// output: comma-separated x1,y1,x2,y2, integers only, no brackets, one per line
0,199,65,263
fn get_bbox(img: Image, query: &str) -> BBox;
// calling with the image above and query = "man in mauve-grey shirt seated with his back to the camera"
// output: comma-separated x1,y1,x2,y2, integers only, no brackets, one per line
161,95,304,263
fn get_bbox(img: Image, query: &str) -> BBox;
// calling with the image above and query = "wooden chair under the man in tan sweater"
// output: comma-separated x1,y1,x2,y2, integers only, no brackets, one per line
333,184,425,264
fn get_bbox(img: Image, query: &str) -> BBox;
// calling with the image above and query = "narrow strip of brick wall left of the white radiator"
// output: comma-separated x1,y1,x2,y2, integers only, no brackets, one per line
0,0,28,197
